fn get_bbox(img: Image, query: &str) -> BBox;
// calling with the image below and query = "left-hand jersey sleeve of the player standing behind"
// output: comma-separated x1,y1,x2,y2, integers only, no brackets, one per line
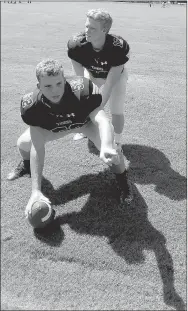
67,34,84,64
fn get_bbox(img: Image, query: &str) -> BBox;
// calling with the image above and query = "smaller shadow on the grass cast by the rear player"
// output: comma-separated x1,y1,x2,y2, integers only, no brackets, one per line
88,140,187,201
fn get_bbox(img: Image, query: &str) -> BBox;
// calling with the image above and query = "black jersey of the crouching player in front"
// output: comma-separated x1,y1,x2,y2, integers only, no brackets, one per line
21,77,102,132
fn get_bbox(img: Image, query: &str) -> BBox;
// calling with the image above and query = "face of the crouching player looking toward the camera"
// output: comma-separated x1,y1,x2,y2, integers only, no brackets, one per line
39,73,65,104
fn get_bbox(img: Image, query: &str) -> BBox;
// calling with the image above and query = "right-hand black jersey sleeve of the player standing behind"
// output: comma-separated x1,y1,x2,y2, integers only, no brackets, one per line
110,36,130,66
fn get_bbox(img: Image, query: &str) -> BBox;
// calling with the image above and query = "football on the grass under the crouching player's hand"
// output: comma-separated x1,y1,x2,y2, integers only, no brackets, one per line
28,201,55,229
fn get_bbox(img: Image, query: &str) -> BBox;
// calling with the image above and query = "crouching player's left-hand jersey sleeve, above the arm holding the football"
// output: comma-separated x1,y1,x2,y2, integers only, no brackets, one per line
20,92,39,126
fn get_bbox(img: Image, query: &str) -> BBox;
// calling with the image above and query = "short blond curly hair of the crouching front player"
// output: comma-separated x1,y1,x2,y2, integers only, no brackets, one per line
36,58,64,81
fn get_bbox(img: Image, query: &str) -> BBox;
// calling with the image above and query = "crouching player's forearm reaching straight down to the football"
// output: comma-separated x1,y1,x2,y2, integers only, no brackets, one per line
30,144,45,192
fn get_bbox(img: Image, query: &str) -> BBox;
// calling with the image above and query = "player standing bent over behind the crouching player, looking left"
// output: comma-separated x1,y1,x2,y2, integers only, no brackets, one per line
68,9,130,143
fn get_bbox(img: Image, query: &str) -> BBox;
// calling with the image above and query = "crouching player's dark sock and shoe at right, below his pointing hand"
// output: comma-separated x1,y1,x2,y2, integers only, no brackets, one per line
116,170,133,205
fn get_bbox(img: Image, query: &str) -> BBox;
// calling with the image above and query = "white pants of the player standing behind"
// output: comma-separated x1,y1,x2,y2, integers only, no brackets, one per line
84,68,128,114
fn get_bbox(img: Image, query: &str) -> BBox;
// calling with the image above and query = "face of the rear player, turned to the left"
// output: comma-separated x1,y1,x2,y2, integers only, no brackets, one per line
85,18,106,43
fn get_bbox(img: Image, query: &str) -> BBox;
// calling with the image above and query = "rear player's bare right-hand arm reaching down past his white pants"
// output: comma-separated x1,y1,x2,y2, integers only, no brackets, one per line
101,65,124,107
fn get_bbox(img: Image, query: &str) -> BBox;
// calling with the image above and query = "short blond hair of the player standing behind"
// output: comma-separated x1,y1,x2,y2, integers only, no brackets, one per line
86,9,113,33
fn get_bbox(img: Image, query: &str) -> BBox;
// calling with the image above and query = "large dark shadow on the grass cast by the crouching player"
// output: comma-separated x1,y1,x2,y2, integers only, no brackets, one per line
40,173,185,310
